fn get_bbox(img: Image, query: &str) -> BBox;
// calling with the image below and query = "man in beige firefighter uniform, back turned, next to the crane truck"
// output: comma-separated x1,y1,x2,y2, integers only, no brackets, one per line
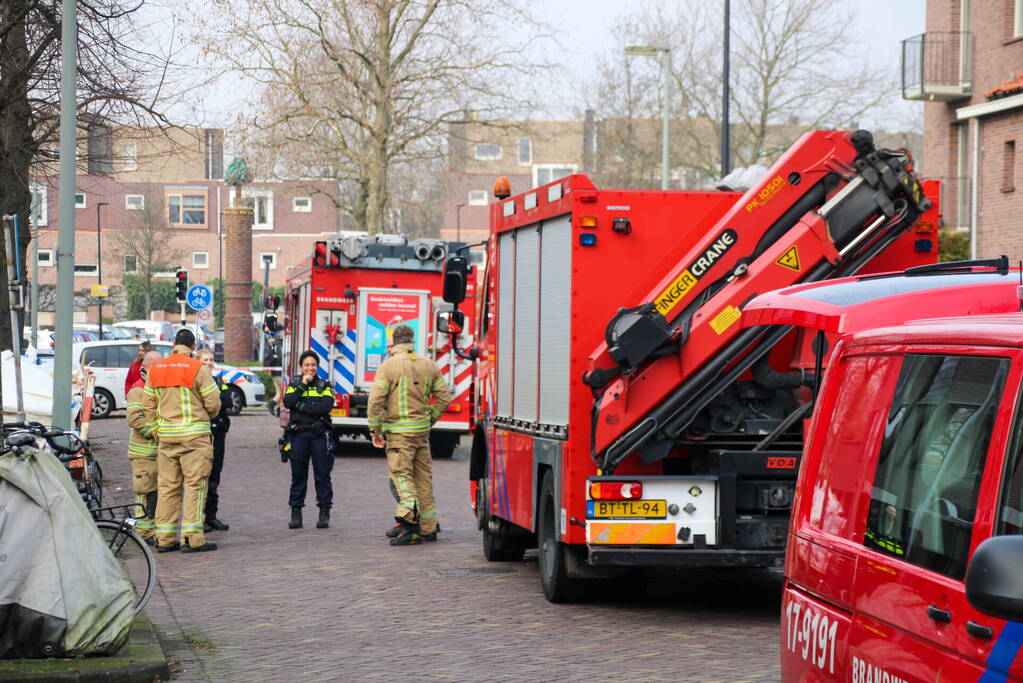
367,325,451,545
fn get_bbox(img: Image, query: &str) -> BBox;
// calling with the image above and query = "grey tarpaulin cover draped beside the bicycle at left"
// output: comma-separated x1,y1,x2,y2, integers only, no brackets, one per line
0,449,135,657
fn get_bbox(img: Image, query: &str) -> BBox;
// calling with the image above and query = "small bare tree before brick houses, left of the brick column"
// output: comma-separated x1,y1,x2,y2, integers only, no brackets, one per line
107,185,184,316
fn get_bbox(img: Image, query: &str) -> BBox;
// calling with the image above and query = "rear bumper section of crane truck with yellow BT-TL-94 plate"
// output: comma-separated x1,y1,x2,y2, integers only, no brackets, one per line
586,451,800,566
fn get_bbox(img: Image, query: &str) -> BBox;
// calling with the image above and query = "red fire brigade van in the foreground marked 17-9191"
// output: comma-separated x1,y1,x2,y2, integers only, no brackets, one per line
743,257,1023,683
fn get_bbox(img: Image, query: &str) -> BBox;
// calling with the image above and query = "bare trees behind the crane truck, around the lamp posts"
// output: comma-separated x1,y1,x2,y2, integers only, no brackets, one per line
596,0,897,187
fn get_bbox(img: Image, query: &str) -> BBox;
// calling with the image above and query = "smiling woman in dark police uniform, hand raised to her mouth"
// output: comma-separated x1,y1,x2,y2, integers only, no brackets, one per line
283,351,336,529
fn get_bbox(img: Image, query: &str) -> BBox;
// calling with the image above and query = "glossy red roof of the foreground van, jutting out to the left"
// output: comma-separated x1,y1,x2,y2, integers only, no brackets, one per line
743,269,1020,333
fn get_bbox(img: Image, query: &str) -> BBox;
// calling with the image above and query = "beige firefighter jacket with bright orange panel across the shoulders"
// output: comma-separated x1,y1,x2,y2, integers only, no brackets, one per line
142,347,220,443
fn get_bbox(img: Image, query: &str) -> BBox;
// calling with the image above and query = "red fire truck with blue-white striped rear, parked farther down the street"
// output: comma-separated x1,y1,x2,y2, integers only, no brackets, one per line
281,235,475,457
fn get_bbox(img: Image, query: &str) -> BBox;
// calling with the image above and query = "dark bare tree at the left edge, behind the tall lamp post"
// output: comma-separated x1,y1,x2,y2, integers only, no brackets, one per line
0,0,186,348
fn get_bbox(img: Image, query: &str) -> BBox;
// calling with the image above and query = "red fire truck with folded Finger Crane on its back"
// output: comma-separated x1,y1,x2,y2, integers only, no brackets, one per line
438,131,938,601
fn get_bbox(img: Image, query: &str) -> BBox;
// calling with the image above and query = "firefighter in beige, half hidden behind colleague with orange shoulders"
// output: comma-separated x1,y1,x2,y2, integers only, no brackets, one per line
126,351,163,545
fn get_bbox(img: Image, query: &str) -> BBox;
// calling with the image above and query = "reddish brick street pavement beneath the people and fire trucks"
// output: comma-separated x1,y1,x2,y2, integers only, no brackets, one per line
92,412,780,683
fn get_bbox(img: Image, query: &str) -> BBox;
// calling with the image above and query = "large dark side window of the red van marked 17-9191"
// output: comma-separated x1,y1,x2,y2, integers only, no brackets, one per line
863,355,1009,579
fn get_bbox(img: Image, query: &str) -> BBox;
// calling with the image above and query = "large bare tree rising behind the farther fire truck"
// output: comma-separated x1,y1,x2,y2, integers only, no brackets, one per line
199,0,556,234
